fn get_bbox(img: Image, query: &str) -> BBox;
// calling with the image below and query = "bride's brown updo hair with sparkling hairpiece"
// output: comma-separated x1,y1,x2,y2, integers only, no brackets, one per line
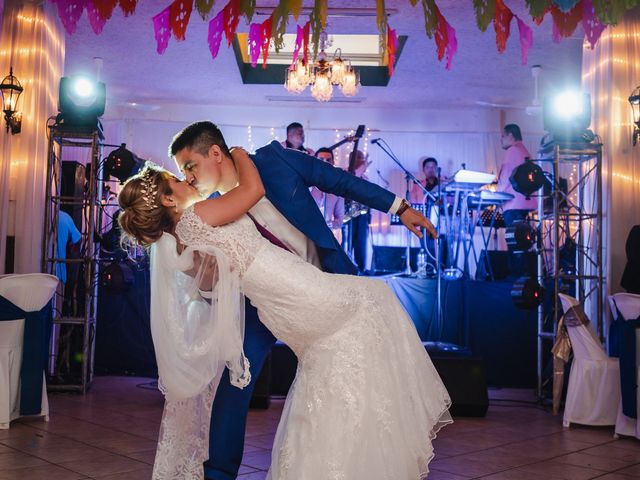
118,163,173,247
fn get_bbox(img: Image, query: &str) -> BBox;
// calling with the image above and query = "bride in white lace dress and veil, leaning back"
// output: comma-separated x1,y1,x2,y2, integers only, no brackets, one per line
119,150,451,480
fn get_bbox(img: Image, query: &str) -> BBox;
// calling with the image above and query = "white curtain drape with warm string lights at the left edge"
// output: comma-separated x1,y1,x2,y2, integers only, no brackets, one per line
0,0,64,273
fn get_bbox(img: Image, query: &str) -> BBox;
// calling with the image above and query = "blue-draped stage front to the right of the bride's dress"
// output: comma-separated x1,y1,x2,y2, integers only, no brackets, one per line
380,275,537,387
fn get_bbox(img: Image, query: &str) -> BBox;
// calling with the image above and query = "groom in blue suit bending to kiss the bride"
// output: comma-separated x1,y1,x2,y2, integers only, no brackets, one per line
169,122,435,480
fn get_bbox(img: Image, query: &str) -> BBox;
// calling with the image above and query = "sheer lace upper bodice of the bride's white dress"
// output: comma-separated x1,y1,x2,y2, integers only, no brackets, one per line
176,206,269,277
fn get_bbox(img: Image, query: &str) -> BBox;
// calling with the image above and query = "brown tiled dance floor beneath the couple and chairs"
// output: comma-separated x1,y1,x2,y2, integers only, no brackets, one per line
0,377,640,480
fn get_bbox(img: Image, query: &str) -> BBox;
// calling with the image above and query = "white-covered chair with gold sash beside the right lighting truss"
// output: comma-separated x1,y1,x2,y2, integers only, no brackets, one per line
558,293,620,427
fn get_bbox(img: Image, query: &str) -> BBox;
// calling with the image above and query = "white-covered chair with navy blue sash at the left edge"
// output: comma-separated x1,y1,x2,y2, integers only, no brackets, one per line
0,273,58,429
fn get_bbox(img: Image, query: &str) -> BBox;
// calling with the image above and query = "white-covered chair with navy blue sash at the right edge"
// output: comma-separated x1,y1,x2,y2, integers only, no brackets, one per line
609,293,640,439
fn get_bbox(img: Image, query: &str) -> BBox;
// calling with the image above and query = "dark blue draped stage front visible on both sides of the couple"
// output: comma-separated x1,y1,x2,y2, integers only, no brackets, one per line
95,270,536,388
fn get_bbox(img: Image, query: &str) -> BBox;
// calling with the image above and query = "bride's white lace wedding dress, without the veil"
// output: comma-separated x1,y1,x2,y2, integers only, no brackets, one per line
152,207,451,480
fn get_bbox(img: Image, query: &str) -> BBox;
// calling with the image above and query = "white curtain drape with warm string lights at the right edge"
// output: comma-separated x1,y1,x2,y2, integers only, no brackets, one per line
582,9,640,293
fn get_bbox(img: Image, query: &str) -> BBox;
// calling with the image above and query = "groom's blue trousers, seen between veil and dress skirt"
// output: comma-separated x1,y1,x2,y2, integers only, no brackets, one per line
204,300,276,480
